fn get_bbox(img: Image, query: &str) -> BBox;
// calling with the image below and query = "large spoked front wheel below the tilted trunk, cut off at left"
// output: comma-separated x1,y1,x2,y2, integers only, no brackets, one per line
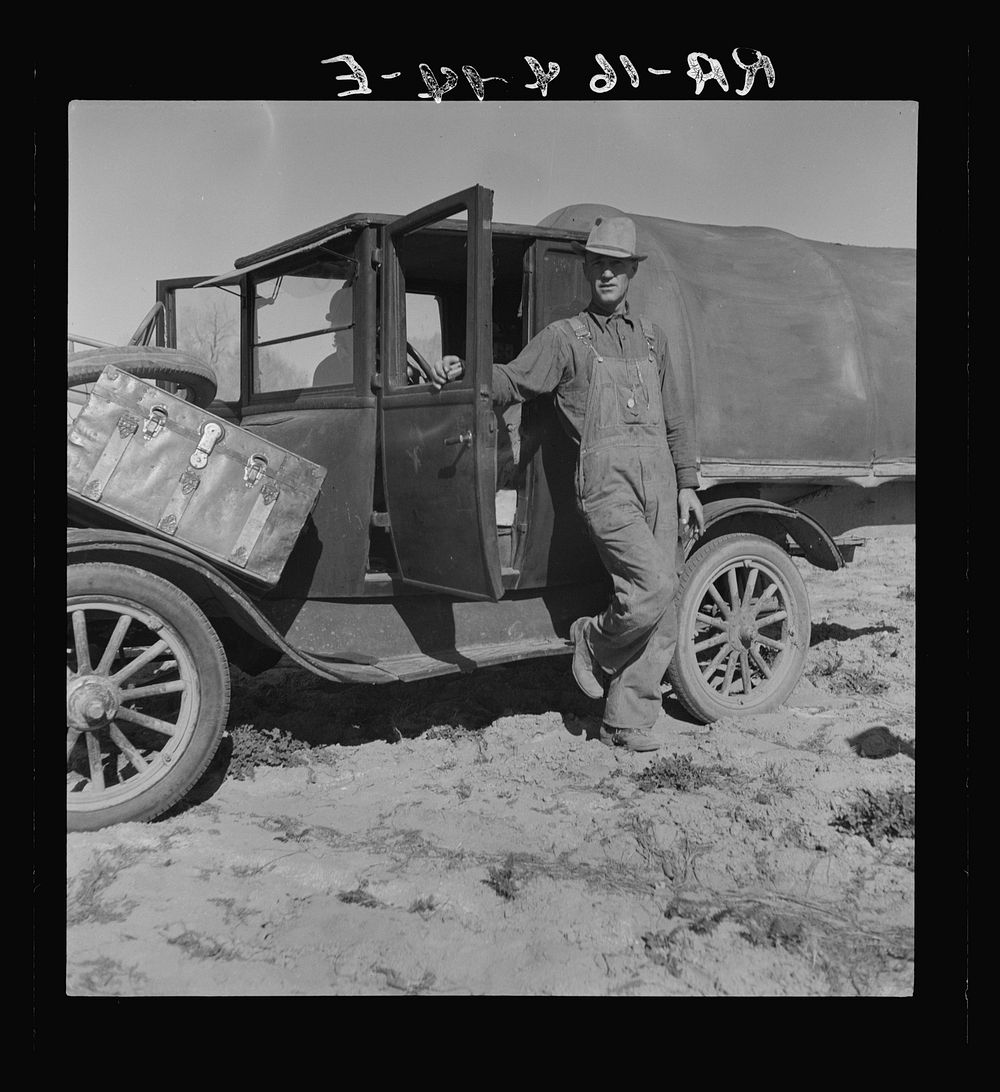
66,562,229,831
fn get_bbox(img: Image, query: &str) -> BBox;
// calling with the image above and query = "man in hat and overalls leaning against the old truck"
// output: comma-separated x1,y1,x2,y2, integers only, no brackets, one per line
428,216,704,751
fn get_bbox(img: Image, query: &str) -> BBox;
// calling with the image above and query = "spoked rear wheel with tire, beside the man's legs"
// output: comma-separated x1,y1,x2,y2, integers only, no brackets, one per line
667,534,811,724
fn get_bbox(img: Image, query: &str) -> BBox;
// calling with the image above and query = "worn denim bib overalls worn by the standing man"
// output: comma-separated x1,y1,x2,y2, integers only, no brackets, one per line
560,318,683,728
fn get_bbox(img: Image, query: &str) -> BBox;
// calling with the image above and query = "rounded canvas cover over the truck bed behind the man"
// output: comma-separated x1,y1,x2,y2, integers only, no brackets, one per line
541,204,916,476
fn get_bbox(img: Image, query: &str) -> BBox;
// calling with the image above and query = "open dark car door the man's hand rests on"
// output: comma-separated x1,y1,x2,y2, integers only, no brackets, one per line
379,186,503,601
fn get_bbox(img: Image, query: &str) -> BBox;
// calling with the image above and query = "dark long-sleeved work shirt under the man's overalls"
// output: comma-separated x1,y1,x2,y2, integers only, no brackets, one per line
493,301,698,489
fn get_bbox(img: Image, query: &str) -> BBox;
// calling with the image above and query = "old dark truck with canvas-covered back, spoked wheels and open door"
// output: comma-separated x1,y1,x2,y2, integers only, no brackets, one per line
67,186,915,830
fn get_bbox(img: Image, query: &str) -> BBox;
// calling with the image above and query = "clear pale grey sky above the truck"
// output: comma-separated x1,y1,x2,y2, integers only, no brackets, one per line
68,99,917,344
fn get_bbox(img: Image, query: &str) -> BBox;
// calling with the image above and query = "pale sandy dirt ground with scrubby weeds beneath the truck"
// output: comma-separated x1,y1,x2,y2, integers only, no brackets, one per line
67,537,915,997
